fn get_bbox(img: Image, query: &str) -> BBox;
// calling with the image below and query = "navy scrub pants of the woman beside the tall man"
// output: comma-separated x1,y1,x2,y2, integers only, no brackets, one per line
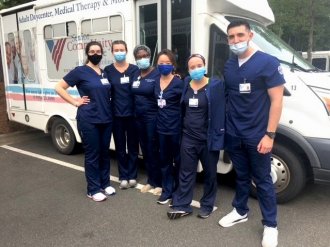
172,134,220,213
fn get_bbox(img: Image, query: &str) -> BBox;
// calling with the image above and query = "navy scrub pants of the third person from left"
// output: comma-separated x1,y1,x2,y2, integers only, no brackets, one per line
136,116,162,187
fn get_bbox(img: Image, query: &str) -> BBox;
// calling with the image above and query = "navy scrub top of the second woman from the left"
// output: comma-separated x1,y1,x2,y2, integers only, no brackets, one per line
104,64,139,117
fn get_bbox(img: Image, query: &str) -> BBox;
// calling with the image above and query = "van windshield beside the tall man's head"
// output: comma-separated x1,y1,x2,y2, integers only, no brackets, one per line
227,17,317,71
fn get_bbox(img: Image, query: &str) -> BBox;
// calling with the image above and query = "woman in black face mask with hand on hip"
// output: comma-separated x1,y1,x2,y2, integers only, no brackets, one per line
55,41,116,201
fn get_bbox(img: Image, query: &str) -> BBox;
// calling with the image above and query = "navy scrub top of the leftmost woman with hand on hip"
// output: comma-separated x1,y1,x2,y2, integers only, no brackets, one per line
63,65,112,123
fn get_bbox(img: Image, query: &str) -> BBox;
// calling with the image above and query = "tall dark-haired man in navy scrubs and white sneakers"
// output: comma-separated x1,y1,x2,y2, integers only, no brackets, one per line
219,20,285,247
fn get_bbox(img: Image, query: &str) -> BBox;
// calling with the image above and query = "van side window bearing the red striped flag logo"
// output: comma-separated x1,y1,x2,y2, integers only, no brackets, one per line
44,21,78,80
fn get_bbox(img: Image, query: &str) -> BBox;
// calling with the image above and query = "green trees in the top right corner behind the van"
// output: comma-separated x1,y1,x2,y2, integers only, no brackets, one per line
268,0,330,51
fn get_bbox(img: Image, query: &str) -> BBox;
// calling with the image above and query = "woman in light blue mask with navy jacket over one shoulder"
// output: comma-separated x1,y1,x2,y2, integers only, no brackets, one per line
167,54,225,219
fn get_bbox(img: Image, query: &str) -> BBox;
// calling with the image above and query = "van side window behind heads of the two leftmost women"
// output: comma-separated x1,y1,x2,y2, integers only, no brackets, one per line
80,15,123,67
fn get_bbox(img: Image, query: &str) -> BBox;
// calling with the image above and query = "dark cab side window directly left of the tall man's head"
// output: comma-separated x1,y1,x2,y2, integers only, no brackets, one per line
208,24,230,79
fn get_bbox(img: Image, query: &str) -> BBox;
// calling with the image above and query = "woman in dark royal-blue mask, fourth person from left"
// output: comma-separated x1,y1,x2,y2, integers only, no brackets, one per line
155,49,183,204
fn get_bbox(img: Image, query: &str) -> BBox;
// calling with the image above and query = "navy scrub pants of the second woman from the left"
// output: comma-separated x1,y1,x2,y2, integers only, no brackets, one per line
113,117,139,180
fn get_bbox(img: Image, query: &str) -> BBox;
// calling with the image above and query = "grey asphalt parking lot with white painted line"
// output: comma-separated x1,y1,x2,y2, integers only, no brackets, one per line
0,131,330,247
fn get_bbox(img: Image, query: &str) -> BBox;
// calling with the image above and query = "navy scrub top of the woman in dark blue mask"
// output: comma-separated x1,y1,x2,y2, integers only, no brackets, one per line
154,76,183,135
